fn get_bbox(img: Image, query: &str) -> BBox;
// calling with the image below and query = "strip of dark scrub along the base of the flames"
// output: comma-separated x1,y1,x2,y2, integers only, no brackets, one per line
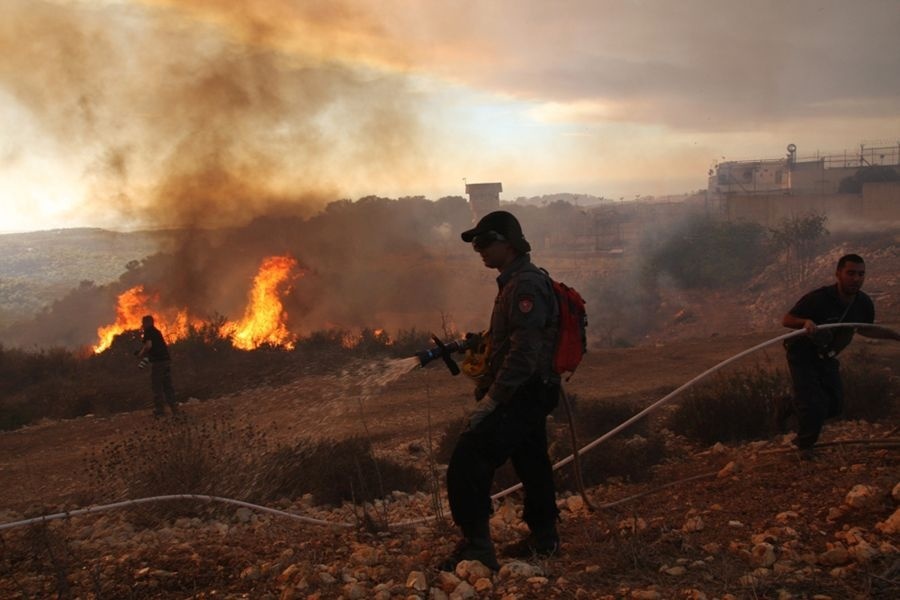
0,324,431,430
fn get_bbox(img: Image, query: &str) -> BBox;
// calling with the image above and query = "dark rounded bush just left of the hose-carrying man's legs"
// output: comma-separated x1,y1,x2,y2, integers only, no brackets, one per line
668,367,790,445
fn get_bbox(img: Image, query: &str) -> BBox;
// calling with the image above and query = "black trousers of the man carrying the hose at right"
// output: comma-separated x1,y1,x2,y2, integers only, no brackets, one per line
788,357,844,448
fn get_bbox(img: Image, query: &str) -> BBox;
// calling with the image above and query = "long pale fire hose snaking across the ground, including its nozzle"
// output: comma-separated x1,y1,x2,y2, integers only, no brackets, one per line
0,323,895,531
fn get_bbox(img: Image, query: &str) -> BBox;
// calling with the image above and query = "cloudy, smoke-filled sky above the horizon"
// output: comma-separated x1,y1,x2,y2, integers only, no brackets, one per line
0,0,900,232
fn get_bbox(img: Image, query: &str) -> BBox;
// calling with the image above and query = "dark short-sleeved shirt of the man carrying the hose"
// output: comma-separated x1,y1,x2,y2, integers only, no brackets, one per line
788,283,875,358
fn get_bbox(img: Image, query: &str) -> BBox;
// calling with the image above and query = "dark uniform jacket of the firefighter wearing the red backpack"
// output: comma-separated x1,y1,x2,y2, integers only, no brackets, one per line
479,254,559,403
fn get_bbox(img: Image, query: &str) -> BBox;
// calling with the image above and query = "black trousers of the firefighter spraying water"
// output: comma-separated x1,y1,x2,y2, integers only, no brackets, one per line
447,381,559,531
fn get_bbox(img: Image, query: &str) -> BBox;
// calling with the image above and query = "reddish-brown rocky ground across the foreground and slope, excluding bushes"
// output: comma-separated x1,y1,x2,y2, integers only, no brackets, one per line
0,331,900,600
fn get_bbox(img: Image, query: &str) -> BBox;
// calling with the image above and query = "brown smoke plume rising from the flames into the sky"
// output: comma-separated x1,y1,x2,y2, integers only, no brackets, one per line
0,0,446,346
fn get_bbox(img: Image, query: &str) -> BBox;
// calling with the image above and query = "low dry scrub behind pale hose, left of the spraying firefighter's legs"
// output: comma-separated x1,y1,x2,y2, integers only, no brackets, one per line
87,417,424,517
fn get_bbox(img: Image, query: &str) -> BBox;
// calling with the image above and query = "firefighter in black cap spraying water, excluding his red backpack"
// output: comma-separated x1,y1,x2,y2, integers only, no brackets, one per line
440,211,559,570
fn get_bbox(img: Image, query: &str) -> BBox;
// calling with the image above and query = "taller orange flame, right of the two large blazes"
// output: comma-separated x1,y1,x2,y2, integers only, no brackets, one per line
219,256,297,350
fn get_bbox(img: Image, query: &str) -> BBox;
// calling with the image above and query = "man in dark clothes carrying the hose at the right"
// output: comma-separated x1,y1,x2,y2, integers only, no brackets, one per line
781,254,900,460
